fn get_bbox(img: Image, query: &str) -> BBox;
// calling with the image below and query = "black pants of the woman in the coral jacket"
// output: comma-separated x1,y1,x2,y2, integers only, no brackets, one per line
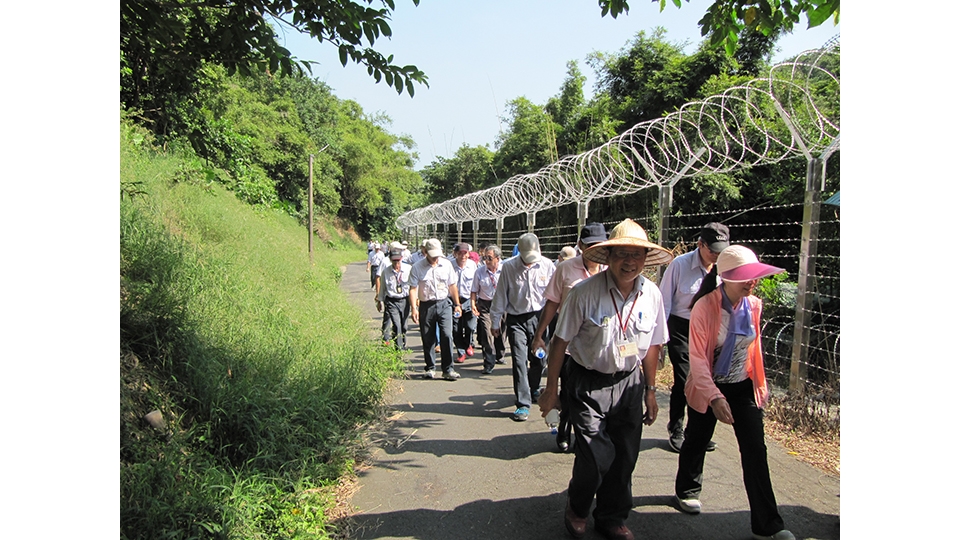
671,378,783,536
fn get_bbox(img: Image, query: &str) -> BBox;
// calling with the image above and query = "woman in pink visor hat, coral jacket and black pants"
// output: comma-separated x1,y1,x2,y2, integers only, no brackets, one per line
675,246,795,540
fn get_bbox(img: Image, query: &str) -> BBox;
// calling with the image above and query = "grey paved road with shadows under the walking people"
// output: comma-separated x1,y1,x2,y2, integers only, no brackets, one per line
340,262,840,540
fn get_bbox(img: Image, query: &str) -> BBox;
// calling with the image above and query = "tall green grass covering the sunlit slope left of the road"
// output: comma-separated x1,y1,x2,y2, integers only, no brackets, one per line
120,122,402,538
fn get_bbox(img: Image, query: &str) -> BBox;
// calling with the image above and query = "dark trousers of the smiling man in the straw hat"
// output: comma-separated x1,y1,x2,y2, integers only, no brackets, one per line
564,360,645,527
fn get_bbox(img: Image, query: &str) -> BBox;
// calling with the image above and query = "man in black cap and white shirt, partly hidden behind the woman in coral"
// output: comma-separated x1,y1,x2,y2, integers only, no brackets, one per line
660,223,730,453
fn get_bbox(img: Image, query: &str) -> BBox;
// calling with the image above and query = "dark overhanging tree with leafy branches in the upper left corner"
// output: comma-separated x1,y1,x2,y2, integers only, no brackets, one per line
120,0,427,145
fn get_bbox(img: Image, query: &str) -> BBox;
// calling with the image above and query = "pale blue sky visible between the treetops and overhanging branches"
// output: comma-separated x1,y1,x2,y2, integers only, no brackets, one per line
281,0,840,168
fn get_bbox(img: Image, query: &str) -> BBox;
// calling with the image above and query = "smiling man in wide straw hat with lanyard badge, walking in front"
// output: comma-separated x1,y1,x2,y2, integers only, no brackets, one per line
539,219,673,540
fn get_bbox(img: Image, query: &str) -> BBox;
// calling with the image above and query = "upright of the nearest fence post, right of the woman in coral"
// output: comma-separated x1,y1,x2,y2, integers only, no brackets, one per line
790,157,824,392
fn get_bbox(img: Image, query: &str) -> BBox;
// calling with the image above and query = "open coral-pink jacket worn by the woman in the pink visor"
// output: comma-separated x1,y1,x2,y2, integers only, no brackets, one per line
684,292,770,414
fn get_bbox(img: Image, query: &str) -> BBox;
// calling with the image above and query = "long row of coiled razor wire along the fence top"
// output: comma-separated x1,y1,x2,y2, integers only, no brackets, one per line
396,39,840,230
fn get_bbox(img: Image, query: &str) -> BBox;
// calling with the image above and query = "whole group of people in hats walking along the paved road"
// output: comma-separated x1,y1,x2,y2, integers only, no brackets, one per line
368,219,794,540
